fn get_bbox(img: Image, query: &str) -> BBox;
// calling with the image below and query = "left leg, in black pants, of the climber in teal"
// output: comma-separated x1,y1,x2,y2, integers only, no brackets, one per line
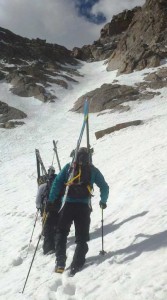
55,203,73,271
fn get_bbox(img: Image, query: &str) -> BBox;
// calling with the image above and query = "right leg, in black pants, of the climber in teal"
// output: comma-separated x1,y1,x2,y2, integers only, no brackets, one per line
71,203,90,273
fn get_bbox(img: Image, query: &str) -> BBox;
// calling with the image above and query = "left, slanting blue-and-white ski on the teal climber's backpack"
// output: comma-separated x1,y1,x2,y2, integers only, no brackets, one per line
59,100,89,212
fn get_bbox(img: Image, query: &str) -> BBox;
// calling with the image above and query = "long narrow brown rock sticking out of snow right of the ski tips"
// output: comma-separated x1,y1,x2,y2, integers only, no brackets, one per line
95,120,143,140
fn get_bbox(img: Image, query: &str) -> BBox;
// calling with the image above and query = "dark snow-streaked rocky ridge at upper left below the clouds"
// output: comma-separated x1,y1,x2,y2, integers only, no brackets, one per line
0,28,80,102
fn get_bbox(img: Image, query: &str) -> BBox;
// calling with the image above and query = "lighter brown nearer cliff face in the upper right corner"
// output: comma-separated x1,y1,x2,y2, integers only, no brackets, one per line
107,0,167,73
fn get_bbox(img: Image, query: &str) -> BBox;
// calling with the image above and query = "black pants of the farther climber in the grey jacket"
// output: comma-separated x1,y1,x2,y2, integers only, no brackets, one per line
43,212,58,254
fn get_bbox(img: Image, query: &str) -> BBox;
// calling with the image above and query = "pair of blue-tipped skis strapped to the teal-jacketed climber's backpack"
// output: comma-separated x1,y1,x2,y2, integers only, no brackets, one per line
59,99,91,212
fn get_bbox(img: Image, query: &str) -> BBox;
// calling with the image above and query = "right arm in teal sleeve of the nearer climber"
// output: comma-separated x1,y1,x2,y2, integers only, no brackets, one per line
93,166,109,204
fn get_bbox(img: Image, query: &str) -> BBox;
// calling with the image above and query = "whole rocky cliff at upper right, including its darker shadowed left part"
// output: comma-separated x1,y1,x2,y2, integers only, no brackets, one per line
72,0,167,73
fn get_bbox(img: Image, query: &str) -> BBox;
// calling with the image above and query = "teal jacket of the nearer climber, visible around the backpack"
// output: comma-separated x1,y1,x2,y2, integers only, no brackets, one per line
49,164,109,204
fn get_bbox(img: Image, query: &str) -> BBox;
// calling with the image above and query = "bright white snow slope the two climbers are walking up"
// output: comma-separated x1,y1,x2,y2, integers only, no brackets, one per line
0,62,167,300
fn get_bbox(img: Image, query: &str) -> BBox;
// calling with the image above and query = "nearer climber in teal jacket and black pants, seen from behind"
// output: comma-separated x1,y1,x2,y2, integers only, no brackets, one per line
47,147,109,275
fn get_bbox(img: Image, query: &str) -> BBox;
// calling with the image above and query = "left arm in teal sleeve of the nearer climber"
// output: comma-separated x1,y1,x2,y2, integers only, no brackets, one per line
49,164,70,203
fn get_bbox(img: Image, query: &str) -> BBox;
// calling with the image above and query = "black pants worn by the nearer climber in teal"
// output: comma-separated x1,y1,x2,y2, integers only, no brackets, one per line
56,202,90,267
